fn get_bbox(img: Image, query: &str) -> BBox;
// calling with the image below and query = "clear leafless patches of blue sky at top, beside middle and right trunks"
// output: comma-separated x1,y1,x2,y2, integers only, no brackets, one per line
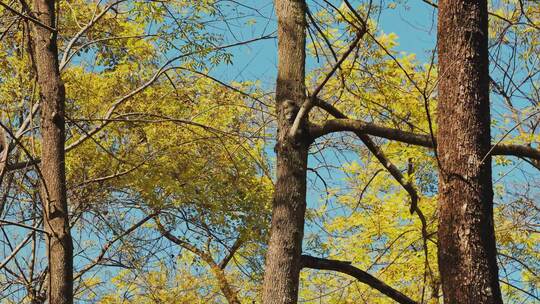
213,0,436,88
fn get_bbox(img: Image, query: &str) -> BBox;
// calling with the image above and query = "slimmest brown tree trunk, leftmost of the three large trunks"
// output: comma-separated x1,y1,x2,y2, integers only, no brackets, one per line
32,0,73,304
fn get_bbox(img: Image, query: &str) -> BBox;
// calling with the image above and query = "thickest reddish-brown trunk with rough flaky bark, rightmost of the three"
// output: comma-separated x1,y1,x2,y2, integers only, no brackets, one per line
437,0,502,304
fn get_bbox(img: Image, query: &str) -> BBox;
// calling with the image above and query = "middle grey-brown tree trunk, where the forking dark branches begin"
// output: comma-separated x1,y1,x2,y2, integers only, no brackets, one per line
263,0,309,304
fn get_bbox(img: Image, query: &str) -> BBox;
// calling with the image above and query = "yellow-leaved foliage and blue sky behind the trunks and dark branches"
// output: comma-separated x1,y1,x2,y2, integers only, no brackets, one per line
0,0,540,303
